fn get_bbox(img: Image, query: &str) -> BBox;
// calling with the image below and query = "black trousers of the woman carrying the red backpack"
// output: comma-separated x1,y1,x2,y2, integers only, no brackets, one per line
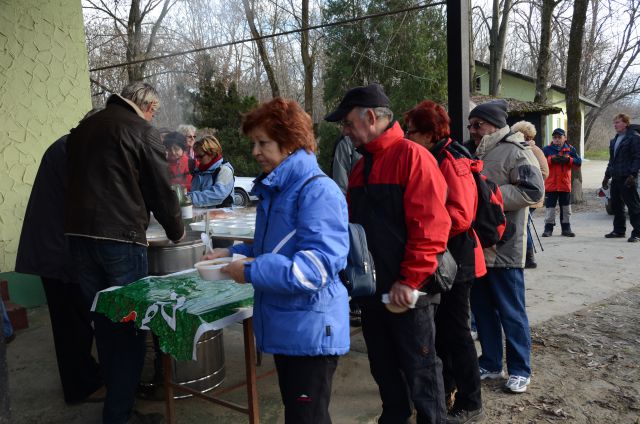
436,280,482,411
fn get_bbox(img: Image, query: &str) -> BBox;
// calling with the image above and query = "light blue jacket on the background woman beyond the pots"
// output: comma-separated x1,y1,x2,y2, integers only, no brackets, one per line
189,158,234,207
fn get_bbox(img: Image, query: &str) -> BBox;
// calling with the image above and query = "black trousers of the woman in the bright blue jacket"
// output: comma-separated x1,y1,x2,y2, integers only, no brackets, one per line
273,355,338,424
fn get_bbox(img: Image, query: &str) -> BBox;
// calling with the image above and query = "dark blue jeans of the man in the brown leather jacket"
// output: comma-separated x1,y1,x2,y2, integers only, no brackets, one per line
69,237,148,424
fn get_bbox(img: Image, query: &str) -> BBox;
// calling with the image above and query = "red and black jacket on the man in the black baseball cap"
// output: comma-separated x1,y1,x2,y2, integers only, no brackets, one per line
347,122,451,307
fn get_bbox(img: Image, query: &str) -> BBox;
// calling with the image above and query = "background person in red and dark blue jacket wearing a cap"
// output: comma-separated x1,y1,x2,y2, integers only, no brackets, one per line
542,128,582,237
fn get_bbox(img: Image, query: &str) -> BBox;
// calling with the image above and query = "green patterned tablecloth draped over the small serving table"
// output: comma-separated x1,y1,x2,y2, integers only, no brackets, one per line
93,270,253,360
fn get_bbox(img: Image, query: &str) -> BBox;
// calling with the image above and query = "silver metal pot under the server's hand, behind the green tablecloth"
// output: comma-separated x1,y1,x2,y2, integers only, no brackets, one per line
147,231,204,275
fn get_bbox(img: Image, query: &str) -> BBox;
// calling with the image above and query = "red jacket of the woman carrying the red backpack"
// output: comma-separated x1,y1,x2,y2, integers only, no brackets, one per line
430,139,487,281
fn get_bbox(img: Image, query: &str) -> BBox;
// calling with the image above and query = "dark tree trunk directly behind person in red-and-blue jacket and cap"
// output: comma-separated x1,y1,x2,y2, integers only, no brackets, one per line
566,0,589,203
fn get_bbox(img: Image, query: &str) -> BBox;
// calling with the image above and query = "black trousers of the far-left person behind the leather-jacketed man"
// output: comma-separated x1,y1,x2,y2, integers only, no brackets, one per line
42,277,103,403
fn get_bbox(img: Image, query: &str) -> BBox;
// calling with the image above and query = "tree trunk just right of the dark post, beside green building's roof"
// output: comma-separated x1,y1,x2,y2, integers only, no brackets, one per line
489,0,512,96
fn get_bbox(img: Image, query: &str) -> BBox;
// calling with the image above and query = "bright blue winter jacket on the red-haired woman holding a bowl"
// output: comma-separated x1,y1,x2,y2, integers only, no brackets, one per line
231,149,349,356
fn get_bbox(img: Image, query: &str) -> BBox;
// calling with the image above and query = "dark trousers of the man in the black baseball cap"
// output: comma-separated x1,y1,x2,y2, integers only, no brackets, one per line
362,304,447,424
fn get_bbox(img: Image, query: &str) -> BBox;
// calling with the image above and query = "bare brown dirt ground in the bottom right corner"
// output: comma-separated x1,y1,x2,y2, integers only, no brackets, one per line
482,287,640,423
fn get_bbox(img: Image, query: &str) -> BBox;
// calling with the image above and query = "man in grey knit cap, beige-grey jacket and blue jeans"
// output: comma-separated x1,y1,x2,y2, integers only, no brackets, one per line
468,100,544,393
